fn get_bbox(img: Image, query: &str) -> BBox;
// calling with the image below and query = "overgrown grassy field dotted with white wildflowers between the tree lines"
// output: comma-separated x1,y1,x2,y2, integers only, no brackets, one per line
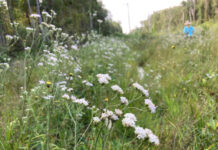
0,13,218,150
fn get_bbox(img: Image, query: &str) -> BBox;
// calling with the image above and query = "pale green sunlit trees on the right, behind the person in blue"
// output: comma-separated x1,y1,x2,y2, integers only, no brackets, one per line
142,0,218,32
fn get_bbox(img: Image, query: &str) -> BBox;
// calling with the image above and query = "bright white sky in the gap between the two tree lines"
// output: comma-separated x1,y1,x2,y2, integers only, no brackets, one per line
101,0,183,33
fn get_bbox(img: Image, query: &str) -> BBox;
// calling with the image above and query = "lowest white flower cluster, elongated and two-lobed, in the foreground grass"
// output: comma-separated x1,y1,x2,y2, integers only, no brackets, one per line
135,127,160,145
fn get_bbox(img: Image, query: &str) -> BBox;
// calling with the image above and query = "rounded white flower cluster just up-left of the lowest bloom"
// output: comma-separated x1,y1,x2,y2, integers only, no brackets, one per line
122,113,137,127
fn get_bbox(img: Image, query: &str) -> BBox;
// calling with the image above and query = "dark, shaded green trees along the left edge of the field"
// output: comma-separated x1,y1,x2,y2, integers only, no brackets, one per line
0,0,122,37
